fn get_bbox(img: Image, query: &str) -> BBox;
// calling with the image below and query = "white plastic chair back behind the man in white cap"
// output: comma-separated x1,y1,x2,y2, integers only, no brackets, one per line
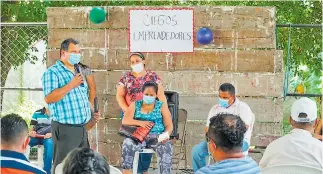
262,164,323,174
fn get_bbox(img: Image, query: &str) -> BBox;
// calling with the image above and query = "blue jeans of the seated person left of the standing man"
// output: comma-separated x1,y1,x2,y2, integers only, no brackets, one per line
29,137,53,174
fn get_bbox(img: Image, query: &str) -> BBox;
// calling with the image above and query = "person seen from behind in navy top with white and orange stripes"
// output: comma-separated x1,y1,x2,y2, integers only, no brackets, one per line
0,114,46,174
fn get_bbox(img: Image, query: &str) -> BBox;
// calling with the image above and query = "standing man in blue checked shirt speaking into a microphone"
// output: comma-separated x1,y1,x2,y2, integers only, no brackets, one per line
42,38,100,172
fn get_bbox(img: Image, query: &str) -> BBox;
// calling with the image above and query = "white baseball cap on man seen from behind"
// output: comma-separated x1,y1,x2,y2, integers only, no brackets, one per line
291,97,317,123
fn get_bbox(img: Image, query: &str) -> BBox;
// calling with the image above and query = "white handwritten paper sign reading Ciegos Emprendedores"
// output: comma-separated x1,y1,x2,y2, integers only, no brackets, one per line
129,8,194,52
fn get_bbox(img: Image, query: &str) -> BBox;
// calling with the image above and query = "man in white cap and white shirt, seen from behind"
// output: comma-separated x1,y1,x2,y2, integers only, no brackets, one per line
259,97,323,169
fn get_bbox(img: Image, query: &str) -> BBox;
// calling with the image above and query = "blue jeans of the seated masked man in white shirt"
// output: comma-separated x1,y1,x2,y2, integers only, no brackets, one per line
192,140,249,173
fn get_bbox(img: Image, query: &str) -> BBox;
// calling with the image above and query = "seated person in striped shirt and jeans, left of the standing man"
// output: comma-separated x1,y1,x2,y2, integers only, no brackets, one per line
29,107,53,174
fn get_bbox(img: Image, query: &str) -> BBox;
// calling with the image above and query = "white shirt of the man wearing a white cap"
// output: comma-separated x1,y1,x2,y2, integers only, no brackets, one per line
259,129,323,169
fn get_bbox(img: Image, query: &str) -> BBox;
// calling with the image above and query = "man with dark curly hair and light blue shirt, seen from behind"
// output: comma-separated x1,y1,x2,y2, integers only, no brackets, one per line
196,113,260,174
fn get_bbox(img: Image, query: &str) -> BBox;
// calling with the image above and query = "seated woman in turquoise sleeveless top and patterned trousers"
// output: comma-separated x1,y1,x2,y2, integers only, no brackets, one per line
122,81,173,174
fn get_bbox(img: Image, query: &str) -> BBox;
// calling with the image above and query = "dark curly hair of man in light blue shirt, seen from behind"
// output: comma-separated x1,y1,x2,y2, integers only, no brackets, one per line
208,113,247,152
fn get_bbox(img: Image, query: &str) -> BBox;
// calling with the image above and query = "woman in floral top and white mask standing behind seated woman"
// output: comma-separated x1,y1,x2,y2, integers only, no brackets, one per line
116,52,168,173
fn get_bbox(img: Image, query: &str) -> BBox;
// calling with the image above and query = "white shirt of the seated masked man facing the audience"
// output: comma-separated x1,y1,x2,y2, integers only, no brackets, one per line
206,97,255,145
